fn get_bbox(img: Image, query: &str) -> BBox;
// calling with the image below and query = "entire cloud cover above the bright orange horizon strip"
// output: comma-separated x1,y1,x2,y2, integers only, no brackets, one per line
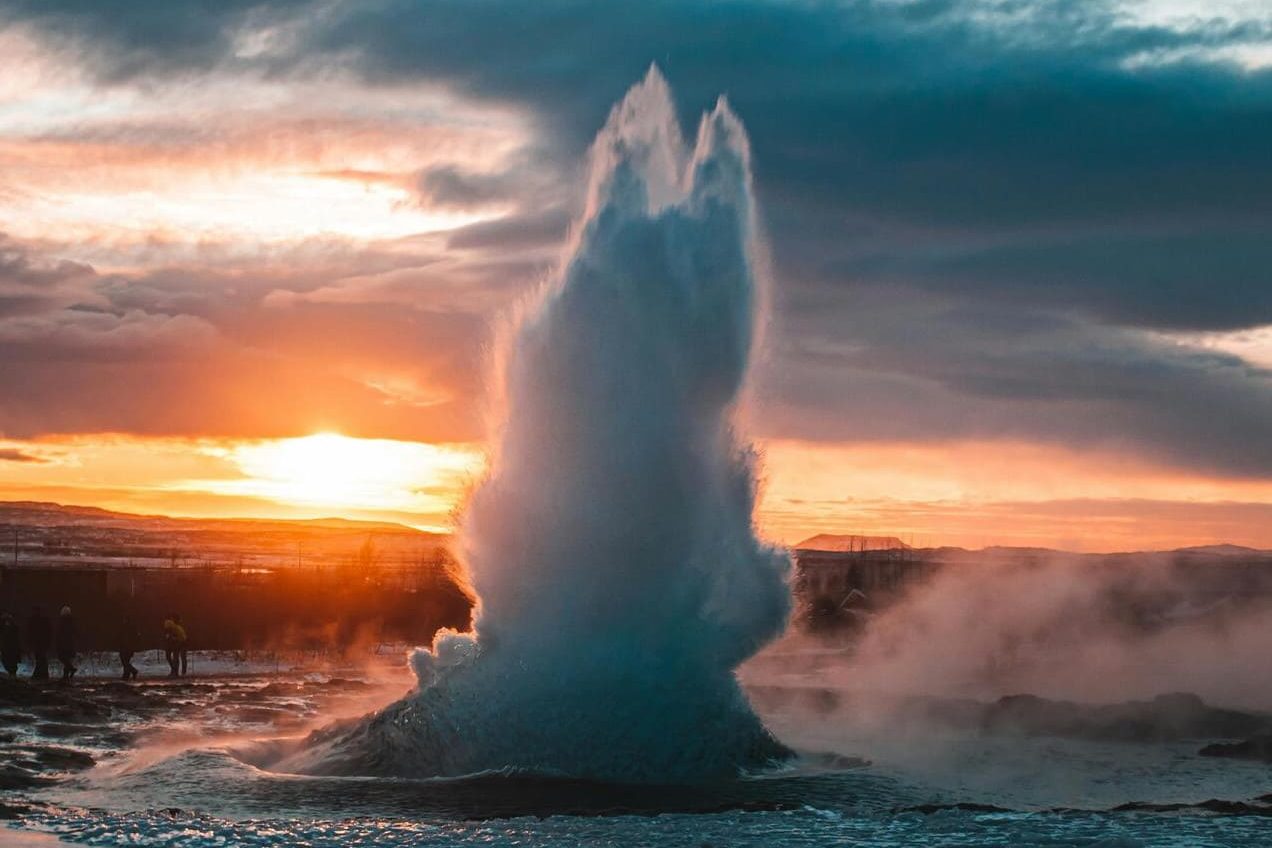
0,0,1272,544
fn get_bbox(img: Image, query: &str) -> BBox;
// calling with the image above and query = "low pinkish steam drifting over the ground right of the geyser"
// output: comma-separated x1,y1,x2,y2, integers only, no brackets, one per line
841,554,1272,708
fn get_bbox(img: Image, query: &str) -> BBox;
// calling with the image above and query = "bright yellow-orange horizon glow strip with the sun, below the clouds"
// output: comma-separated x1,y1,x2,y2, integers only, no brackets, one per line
7,432,1272,552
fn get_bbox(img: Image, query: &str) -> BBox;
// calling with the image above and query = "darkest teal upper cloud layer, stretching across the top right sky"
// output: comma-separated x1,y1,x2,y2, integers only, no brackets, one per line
13,0,1272,328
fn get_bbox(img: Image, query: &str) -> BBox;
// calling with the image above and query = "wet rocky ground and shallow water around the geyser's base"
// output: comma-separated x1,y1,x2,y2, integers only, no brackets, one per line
7,664,1272,848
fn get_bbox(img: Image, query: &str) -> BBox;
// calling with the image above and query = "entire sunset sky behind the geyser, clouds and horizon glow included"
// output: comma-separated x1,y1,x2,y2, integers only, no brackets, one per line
0,0,1272,551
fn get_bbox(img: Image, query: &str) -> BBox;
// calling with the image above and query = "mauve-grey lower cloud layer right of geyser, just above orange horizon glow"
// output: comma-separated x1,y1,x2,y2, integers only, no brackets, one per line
759,285,1272,478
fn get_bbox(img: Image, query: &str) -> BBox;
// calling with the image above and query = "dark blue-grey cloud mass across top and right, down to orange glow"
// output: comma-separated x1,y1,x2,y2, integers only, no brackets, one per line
9,0,1272,475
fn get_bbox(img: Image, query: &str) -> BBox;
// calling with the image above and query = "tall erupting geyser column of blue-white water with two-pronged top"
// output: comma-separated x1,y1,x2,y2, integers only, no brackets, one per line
287,69,790,782
